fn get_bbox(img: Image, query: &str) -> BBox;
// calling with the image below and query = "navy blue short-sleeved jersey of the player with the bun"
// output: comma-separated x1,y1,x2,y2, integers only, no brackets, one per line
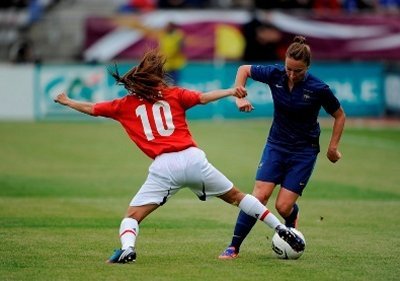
250,65,340,151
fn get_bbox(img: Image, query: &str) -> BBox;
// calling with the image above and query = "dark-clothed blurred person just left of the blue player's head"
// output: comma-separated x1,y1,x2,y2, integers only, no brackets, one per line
242,15,282,62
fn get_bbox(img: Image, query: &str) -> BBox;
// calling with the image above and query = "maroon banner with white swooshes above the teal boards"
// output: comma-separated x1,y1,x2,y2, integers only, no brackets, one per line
84,10,400,62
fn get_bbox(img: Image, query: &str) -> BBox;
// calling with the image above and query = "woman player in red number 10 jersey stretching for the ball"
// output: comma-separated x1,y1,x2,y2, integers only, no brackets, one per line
54,49,304,263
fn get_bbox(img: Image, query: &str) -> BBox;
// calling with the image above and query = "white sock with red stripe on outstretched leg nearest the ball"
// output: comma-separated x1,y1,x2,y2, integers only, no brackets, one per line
239,194,283,230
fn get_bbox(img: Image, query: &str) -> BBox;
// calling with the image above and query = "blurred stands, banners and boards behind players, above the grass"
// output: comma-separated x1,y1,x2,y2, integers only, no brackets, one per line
0,0,400,120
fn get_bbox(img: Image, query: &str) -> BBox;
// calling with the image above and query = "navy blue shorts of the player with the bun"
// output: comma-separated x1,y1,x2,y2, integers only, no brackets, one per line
256,145,318,195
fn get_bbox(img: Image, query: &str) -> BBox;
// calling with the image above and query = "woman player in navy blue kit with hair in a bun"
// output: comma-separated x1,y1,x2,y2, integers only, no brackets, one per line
219,36,345,259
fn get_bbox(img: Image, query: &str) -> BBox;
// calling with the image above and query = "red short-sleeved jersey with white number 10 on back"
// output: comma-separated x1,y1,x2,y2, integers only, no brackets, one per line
93,87,201,159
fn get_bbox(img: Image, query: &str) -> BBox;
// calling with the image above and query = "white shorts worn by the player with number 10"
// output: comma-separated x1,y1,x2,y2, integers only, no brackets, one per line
129,147,233,206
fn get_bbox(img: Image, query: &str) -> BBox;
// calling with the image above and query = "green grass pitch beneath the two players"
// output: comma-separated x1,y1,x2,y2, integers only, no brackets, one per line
0,120,400,281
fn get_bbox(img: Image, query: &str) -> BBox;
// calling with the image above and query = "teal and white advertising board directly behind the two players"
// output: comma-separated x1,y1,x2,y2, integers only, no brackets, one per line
35,63,385,119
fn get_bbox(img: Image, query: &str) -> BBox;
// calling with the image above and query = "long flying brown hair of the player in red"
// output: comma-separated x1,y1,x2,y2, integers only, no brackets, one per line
109,49,168,102
